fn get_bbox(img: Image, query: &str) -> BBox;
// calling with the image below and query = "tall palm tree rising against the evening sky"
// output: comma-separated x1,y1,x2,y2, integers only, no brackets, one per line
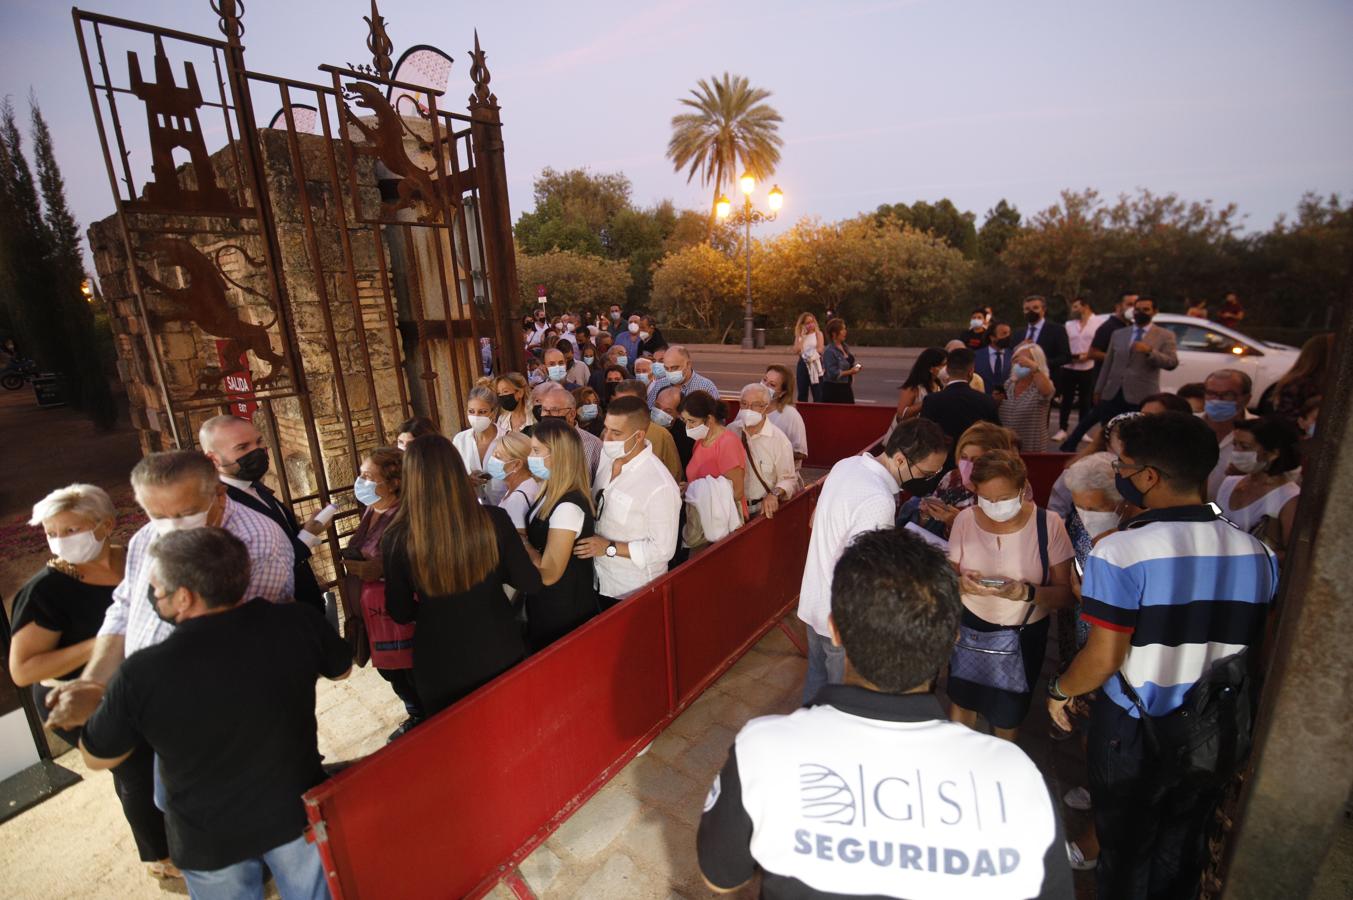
667,72,785,237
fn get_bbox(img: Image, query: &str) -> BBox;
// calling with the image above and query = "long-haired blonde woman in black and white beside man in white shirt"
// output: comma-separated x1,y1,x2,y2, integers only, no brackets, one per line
526,418,601,651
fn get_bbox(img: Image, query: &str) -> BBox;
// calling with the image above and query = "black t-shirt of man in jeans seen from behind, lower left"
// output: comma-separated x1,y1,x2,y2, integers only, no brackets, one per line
84,600,352,870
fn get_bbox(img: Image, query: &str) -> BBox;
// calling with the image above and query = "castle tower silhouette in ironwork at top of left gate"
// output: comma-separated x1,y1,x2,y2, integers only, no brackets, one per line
127,34,245,215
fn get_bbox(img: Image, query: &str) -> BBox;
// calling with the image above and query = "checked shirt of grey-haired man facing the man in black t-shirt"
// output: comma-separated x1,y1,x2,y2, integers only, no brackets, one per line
99,497,296,656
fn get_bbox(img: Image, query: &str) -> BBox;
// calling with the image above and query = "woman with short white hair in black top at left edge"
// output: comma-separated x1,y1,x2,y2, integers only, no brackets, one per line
9,485,179,878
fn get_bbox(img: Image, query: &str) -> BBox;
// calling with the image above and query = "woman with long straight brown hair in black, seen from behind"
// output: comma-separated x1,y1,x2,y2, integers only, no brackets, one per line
380,434,541,716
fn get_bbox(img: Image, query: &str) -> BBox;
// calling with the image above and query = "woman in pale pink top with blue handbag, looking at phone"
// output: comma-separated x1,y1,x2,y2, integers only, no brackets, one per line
948,451,1076,740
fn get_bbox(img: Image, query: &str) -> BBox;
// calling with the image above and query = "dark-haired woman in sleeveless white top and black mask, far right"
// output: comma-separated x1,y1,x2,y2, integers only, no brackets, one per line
1216,415,1302,562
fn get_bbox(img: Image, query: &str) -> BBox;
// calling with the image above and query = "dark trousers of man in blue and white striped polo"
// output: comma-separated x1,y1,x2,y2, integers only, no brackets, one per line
1085,694,1226,900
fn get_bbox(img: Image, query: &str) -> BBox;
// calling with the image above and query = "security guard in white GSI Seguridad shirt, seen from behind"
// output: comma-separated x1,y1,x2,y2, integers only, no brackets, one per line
697,529,1073,900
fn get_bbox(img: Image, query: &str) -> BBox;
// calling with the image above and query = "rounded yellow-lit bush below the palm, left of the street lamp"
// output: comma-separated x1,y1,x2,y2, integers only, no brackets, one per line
652,244,746,329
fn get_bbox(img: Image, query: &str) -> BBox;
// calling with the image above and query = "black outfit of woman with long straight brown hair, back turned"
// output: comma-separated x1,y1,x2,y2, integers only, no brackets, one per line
380,506,541,716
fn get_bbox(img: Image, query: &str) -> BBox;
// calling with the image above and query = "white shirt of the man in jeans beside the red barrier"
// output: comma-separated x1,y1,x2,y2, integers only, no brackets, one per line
798,453,901,637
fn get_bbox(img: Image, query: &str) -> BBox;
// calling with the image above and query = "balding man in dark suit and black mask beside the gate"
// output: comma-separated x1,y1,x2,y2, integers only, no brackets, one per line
198,415,325,613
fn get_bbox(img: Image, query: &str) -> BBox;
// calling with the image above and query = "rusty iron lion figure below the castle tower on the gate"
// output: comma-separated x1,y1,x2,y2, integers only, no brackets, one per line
137,237,287,390
